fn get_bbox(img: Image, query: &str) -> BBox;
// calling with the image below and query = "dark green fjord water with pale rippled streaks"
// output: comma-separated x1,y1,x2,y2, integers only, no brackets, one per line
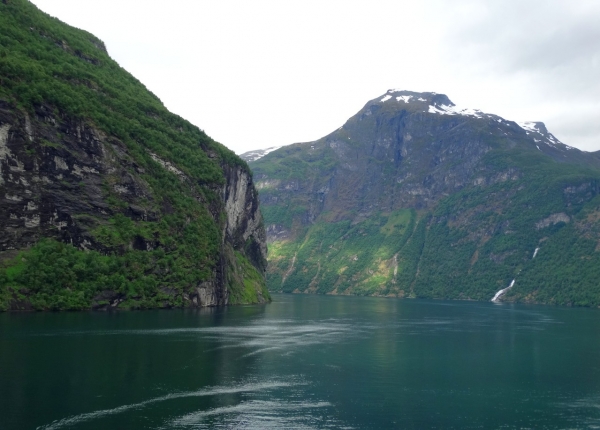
0,295,600,429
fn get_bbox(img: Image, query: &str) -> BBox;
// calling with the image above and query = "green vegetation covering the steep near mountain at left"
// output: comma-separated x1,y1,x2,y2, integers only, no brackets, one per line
0,0,264,309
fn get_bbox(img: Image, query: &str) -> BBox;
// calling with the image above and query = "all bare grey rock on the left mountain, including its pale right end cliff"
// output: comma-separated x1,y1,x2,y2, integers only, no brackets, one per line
0,102,267,307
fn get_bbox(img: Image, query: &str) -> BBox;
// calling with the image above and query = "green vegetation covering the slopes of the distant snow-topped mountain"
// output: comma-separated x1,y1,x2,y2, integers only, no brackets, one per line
251,112,600,306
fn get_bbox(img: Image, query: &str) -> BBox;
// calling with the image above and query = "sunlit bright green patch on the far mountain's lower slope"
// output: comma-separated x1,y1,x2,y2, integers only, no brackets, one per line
268,210,417,295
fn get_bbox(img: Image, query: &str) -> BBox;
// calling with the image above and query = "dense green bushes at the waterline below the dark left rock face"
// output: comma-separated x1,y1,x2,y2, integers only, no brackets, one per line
0,239,176,310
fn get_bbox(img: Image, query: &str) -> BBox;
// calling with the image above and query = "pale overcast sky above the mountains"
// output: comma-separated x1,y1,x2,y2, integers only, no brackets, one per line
33,0,600,153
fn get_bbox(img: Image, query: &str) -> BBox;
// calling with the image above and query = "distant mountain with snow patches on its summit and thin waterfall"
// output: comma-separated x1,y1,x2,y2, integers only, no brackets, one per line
250,90,600,306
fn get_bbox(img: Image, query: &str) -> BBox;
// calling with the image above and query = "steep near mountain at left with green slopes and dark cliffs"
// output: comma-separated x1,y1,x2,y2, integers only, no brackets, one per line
0,0,269,310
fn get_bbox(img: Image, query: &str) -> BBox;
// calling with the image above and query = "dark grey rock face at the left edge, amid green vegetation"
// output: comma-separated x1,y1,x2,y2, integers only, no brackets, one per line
0,106,139,252
